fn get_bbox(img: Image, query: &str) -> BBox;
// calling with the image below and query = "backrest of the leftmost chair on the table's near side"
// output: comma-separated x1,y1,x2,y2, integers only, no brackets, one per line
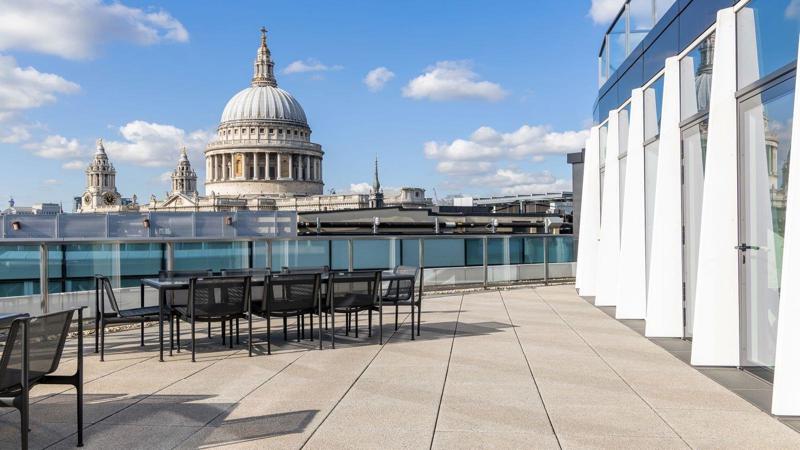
189,277,250,315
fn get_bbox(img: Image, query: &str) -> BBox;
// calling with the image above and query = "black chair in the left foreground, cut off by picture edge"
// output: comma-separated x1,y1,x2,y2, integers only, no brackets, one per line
0,308,83,449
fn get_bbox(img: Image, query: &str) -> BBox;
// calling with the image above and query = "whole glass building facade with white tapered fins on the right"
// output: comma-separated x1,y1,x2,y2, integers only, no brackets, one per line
576,0,800,416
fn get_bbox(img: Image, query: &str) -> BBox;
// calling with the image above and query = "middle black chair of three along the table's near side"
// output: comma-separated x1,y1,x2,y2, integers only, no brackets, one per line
253,273,322,354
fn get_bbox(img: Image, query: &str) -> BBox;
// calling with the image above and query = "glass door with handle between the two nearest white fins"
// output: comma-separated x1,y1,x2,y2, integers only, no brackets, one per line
739,79,794,368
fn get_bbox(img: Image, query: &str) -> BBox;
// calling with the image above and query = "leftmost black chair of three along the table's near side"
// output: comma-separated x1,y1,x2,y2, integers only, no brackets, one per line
174,277,248,361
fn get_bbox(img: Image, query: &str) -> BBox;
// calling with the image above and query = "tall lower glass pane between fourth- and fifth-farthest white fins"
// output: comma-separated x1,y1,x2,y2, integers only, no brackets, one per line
681,120,708,338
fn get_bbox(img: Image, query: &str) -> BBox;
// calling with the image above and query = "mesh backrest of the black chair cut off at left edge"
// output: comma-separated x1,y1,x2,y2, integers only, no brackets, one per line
0,309,77,391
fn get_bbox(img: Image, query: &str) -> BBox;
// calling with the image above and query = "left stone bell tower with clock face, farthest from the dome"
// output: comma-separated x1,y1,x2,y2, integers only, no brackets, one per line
79,139,122,212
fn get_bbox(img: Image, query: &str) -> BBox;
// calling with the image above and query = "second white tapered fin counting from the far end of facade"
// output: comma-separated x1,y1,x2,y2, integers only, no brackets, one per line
595,110,620,306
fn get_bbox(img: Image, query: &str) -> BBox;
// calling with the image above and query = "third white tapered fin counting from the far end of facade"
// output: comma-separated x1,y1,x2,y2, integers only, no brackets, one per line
616,89,647,319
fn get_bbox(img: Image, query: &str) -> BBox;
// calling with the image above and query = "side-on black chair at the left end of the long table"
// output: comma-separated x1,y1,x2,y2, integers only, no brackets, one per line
94,275,159,361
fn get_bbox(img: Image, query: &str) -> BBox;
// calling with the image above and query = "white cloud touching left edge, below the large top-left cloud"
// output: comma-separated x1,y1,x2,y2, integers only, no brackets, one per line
0,55,80,118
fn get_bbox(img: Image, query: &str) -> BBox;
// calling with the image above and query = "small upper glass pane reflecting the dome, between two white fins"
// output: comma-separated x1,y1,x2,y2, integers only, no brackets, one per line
681,33,715,119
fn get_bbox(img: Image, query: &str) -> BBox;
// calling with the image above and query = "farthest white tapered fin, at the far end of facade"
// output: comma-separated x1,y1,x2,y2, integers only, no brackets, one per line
575,127,600,297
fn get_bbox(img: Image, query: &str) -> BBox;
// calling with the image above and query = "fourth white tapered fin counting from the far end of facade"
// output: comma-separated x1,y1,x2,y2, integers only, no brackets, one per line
645,57,683,337
